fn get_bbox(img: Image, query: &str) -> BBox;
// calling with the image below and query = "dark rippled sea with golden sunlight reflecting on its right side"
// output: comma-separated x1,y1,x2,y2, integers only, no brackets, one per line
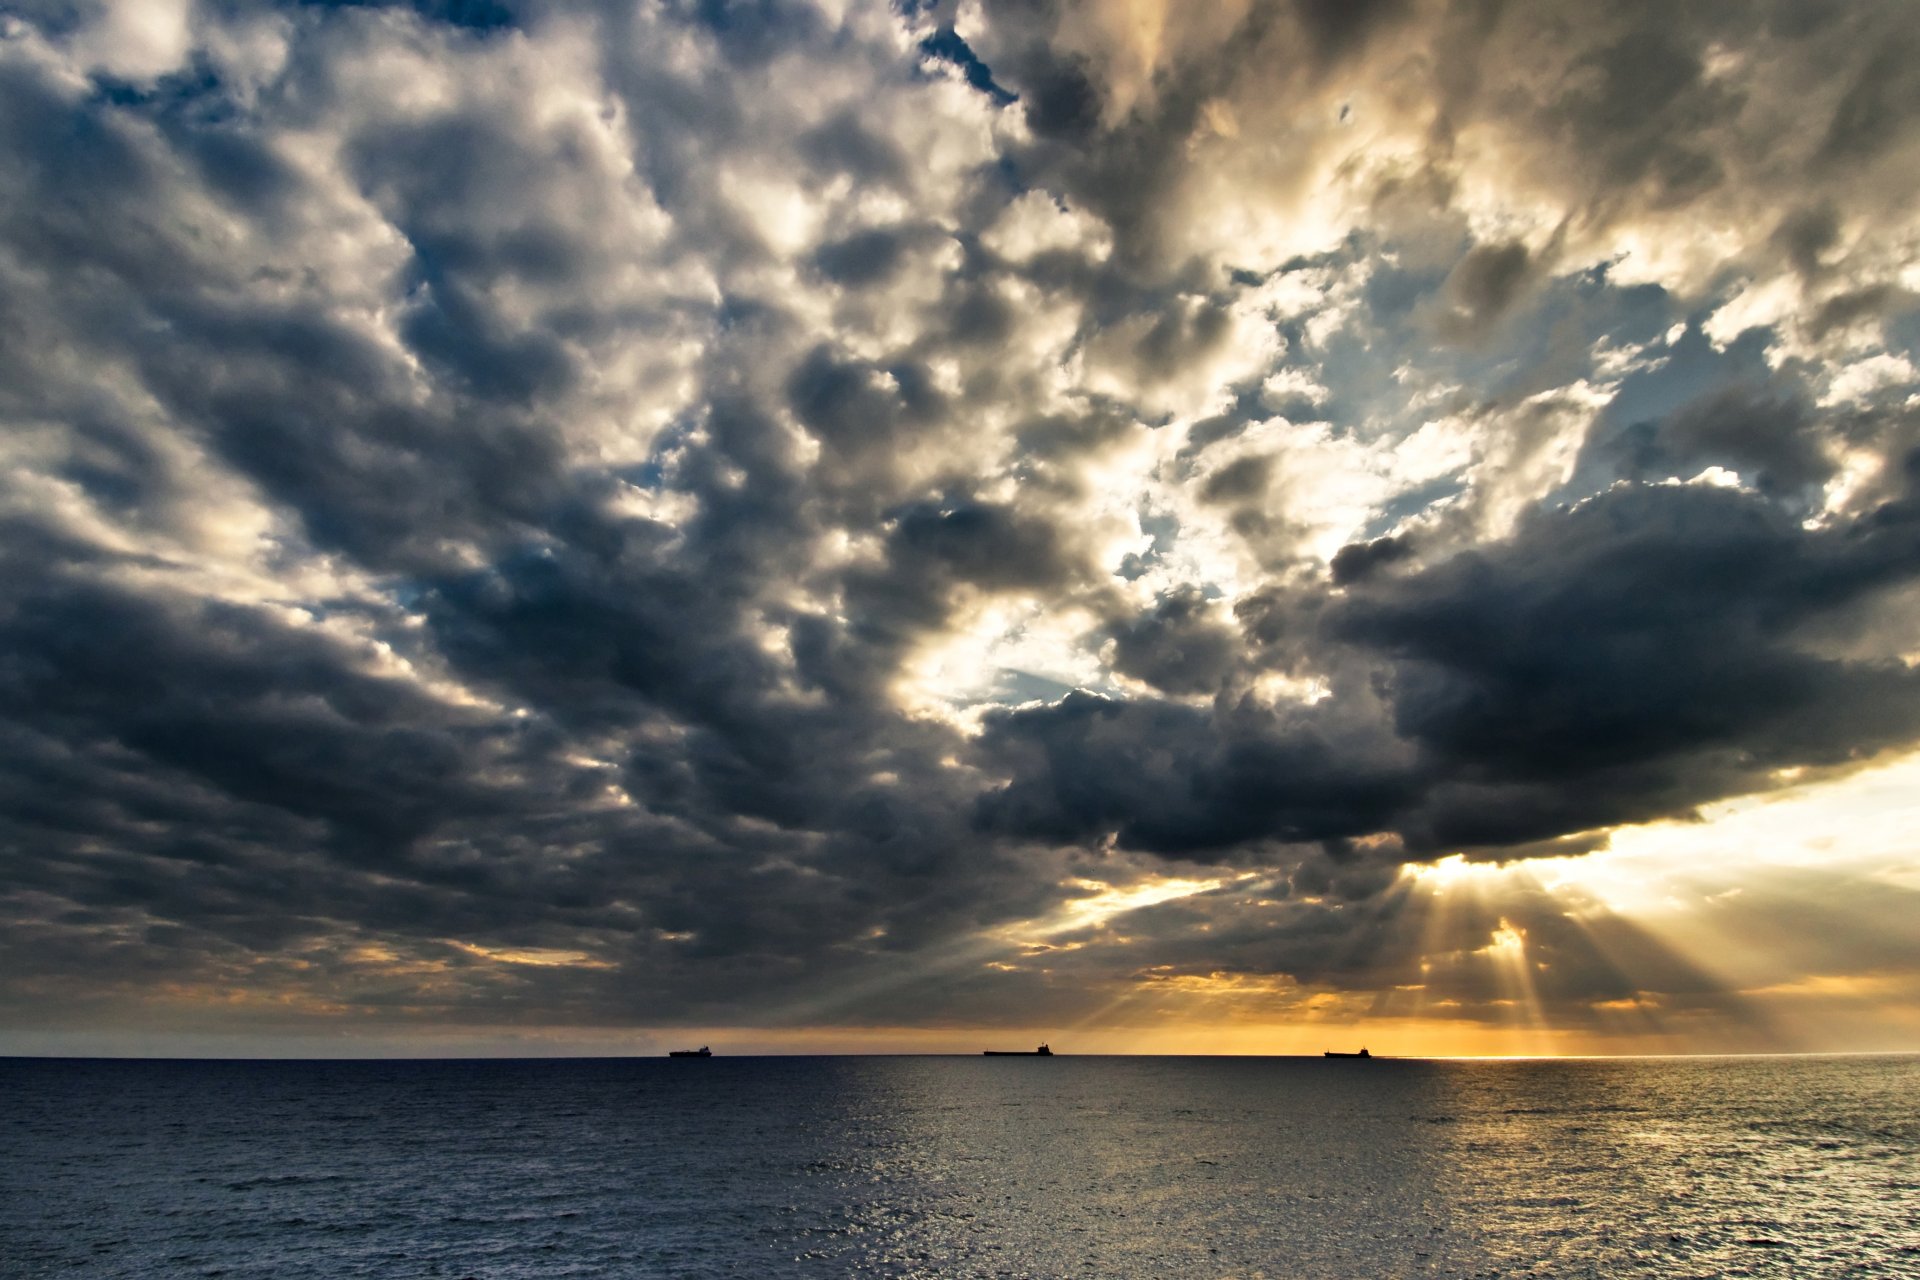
0,1055,1920,1280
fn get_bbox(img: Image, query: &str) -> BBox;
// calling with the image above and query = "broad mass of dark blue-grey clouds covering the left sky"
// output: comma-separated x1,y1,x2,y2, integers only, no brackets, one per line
6,6,1056,1021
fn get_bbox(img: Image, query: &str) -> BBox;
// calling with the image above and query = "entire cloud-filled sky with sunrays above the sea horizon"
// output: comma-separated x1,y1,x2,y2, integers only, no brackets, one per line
0,0,1920,1055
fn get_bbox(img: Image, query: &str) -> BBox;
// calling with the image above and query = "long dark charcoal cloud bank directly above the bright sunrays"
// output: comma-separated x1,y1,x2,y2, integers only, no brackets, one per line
981,466,1920,856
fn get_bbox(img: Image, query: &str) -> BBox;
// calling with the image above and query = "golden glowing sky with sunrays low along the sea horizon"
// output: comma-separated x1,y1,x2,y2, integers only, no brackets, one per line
22,756,1920,1057
